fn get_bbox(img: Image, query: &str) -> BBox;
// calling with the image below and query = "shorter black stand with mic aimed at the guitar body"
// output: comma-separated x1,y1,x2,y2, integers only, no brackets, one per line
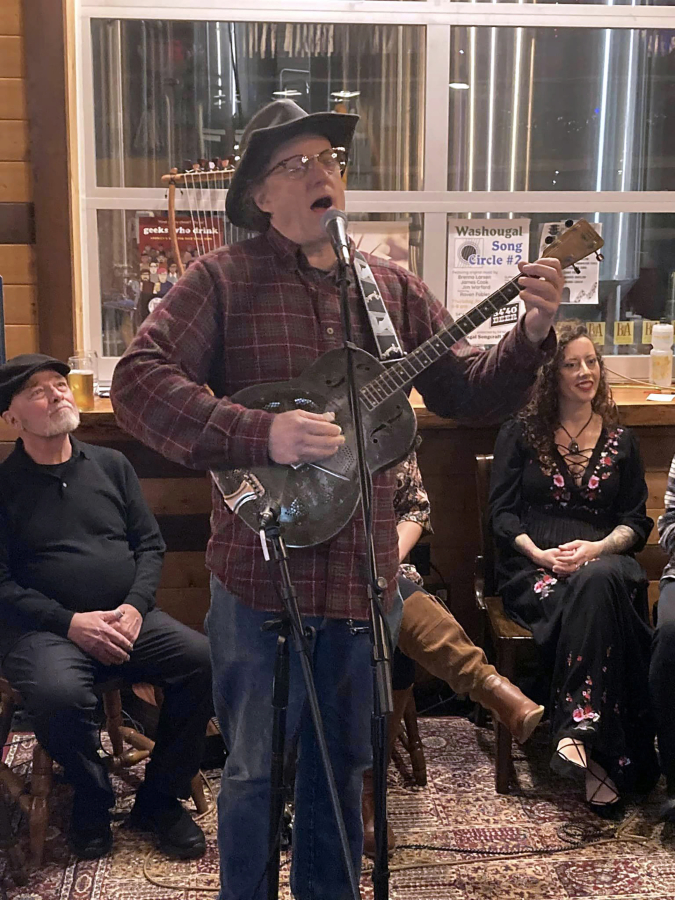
260,506,361,900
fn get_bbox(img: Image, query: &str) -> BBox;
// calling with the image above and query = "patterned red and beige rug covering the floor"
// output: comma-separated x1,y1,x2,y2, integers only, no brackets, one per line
0,718,675,900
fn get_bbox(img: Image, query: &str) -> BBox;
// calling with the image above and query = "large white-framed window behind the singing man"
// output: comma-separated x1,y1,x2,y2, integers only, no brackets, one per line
78,0,675,379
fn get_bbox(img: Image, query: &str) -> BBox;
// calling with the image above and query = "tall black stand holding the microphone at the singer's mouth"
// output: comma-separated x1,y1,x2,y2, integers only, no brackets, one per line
332,248,394,900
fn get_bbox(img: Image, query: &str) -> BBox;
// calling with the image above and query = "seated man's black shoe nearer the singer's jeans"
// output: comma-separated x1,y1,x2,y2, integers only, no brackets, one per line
129,786,206,859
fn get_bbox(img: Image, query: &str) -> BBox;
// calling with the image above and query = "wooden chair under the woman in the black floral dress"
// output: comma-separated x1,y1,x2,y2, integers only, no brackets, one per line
474,455,536,794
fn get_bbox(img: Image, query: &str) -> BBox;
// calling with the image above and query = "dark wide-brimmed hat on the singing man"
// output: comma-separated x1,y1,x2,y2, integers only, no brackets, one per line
225,100,359,231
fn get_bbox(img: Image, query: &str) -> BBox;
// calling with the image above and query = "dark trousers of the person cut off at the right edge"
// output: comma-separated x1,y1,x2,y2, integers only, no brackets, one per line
649,581,675,795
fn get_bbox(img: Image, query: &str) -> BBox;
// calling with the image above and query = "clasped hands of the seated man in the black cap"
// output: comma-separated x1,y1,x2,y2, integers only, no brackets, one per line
68,603,143,666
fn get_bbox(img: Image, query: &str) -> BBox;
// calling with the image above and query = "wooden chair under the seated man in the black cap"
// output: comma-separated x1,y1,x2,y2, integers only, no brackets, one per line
0,673,208,867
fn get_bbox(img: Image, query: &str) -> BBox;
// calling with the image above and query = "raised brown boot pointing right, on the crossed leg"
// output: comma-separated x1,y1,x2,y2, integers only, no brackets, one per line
398,591,544,744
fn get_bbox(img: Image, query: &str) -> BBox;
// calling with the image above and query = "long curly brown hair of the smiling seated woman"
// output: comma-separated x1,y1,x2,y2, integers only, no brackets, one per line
518,322,619,466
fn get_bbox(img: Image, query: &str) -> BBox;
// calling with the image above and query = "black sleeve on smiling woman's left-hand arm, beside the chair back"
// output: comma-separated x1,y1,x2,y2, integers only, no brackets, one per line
489,421,527,549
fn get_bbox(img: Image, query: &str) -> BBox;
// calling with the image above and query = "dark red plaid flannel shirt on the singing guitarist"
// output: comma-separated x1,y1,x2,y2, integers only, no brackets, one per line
111,228,555,619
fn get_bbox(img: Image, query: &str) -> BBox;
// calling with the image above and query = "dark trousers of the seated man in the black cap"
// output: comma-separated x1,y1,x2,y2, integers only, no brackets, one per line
2,609,212,816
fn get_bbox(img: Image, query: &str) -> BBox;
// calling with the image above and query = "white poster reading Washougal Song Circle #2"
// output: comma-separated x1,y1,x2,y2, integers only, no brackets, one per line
448,219,530,346
